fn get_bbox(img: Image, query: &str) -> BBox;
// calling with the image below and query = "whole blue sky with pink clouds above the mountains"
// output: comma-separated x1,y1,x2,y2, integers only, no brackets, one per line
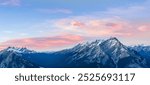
0,0,150,51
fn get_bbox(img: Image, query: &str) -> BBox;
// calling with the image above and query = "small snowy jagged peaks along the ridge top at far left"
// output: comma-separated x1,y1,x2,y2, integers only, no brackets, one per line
4,47,35,53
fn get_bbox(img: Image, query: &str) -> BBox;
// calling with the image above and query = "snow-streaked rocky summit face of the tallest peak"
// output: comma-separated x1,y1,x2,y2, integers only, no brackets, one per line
100,38,130,64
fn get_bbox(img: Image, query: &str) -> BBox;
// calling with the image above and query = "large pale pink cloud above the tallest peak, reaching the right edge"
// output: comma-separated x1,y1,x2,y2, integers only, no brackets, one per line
52,16,150,38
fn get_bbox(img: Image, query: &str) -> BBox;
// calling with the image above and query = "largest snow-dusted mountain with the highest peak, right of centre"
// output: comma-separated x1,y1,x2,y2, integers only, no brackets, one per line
66,38,146,67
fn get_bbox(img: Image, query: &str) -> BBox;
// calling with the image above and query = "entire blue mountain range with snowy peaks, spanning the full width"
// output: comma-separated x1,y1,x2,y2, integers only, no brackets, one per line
0,38,150,68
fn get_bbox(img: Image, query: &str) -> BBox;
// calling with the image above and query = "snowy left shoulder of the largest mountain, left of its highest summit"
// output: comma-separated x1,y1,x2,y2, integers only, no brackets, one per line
66,40,109,67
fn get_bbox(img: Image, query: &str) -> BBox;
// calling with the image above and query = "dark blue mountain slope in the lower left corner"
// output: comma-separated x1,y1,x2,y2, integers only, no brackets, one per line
0,51,39,68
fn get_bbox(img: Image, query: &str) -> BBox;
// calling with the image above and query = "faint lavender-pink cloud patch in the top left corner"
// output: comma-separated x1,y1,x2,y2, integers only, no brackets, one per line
0,0,21,6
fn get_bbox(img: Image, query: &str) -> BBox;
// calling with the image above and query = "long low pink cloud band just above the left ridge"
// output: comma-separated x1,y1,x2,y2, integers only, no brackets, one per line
0,34,84,50
